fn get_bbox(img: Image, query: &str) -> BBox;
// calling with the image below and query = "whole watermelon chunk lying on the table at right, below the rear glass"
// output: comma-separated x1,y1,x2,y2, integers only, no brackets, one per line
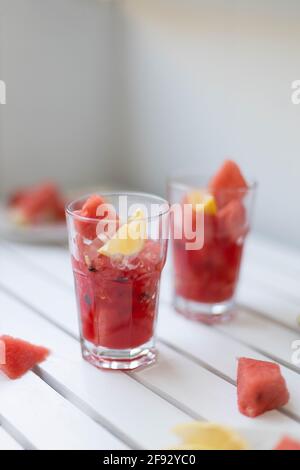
237,358,289,418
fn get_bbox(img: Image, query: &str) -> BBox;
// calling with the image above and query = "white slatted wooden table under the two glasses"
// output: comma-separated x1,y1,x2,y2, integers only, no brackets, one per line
0,237,300,450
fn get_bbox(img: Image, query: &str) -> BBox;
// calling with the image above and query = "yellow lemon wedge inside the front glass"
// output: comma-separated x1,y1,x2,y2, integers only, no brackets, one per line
98,209,147,256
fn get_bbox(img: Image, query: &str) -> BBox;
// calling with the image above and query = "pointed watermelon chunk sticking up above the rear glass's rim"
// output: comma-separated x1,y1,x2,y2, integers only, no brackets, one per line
209,160,248,208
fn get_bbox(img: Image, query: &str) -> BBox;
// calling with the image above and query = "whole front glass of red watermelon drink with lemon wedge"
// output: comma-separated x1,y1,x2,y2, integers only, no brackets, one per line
67,194,169,369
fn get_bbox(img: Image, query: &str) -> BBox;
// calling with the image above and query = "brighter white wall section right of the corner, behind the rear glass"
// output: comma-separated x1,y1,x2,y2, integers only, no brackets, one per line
111,0,300,247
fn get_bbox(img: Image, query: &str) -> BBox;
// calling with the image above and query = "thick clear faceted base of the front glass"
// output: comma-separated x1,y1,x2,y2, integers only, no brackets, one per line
81,339,157,370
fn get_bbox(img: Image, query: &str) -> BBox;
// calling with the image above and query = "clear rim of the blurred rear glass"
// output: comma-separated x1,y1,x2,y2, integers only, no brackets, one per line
167,173,258,194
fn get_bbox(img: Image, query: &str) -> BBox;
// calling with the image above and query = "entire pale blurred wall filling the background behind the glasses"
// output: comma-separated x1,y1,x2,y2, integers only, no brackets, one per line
0,0,300,247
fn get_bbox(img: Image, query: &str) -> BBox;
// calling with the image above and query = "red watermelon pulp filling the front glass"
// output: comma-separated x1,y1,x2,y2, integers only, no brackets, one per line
73,240,164,349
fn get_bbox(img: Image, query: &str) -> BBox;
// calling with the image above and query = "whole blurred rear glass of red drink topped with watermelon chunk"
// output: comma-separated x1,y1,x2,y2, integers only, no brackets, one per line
169,161,255,323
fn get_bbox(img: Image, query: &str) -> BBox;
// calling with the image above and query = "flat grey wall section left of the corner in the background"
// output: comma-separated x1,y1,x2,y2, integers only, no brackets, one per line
0,0,116,191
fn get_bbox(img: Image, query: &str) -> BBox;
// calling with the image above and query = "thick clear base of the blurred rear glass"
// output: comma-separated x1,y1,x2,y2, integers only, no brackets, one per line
174,295,236,325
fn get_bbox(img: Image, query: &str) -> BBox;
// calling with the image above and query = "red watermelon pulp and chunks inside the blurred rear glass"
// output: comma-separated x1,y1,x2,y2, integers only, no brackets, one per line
173,201,247,303
